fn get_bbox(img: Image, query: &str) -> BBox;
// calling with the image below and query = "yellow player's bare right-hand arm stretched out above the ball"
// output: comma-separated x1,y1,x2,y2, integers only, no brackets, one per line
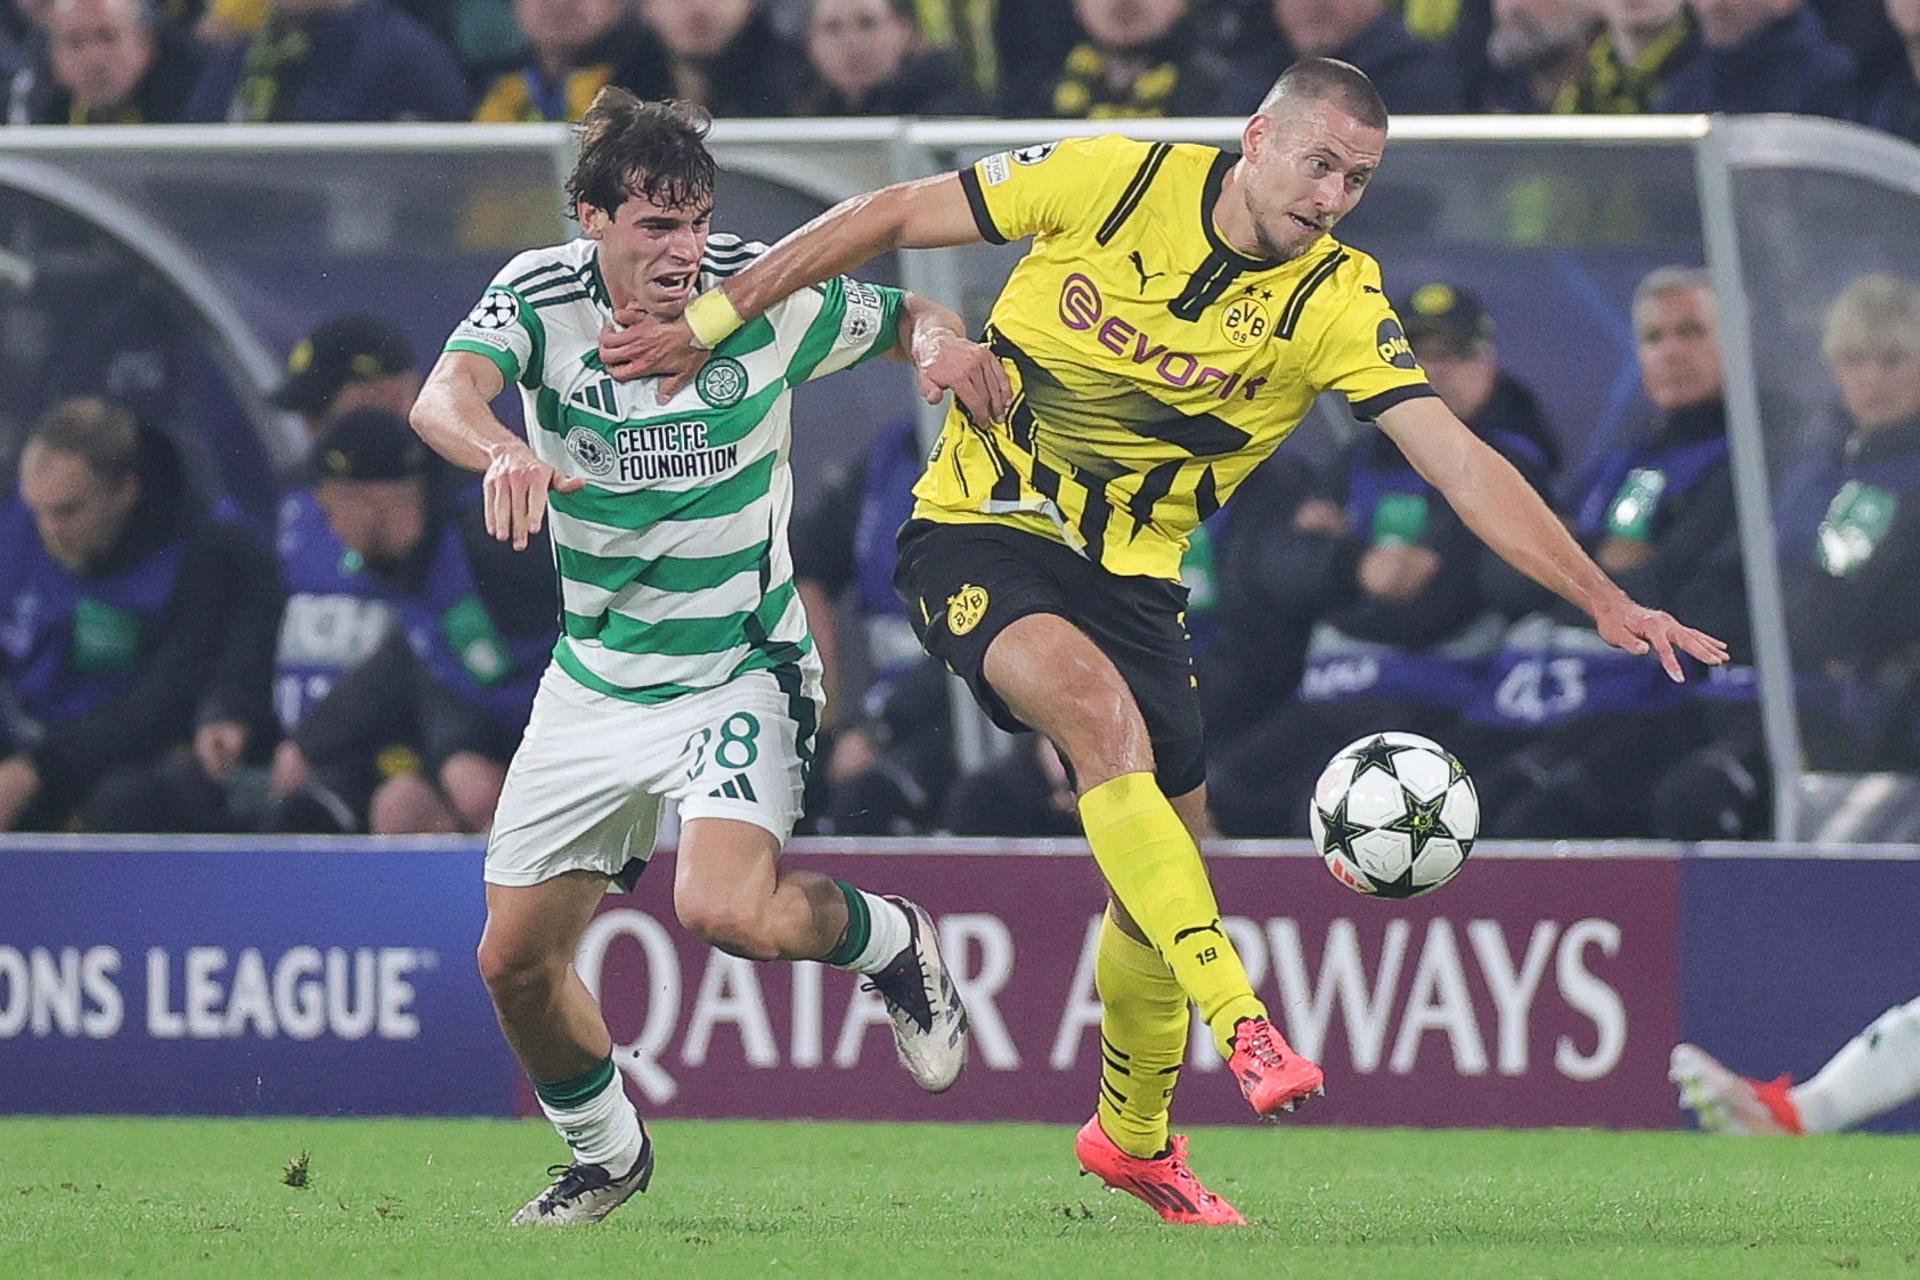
1380,395,1726,681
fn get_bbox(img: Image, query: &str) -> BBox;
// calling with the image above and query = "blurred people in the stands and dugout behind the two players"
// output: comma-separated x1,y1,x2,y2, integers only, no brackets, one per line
11,0,1920,852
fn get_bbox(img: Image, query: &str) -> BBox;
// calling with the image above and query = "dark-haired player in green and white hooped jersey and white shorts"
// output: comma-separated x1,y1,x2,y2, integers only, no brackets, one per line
413,88,1008,1224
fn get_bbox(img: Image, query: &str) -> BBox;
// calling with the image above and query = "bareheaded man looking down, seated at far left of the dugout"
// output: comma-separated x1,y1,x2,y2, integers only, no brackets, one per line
0,399,278,831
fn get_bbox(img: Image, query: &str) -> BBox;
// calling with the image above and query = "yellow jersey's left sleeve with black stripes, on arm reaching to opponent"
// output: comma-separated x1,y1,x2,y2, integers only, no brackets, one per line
960,134,1144,244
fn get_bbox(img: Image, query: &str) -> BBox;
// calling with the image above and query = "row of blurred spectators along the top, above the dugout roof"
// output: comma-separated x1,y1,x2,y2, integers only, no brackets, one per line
0,0,1920,138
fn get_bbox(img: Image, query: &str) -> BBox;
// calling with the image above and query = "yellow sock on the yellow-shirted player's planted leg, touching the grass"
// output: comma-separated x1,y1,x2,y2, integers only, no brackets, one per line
1092,915,1188,1159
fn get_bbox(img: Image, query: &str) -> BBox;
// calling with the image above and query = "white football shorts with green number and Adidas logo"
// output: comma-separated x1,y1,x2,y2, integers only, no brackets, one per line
486,662,822,887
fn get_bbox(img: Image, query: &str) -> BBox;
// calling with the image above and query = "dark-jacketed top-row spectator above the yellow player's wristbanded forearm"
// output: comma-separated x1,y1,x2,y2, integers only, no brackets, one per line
795,0,987,115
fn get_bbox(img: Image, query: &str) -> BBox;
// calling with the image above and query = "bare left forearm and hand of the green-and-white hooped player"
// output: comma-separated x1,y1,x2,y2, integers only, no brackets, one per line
407,351,586,551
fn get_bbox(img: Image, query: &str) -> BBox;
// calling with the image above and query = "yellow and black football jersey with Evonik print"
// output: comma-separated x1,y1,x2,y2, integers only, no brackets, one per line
914,134,1432,578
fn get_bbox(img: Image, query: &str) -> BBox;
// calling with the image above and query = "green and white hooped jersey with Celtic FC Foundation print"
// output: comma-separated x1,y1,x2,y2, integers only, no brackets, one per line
445,234,902,702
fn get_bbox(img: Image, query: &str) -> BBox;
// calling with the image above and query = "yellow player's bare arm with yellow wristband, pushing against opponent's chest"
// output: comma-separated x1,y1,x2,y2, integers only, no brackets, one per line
601,173,981,397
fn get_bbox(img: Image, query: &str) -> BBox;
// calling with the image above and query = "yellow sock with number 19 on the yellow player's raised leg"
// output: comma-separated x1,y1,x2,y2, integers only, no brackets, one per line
1079,773,1267,1057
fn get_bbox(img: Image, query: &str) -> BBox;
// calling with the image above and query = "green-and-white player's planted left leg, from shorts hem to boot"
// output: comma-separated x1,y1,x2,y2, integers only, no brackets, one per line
480,871,653,1226
